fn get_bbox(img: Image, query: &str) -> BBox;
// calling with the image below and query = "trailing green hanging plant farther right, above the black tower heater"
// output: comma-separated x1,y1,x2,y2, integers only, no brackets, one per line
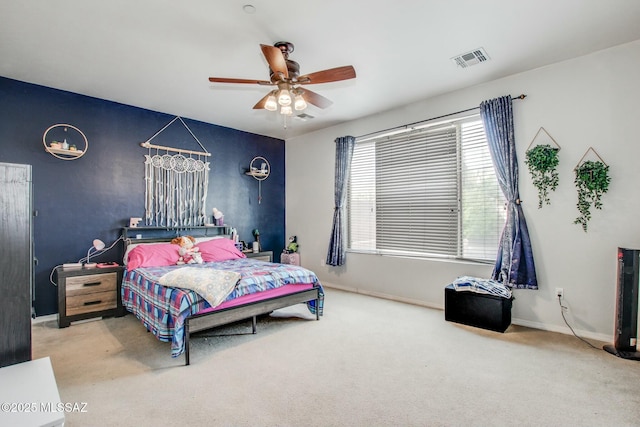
573,160,611,232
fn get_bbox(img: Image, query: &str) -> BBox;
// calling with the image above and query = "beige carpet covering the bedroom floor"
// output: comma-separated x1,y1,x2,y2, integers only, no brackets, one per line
33,289,640,427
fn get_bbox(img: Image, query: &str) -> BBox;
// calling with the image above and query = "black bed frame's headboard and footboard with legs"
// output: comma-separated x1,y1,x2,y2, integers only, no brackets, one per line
122,226,320,365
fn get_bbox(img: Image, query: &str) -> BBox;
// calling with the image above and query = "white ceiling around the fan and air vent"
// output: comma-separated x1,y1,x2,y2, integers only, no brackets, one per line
0,0,640,139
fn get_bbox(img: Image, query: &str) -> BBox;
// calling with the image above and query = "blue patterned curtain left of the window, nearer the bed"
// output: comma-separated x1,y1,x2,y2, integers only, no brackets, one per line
327,136,356,267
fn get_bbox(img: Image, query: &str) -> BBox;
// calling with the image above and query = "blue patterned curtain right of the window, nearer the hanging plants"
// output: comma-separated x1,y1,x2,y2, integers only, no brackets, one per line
480,96,538,289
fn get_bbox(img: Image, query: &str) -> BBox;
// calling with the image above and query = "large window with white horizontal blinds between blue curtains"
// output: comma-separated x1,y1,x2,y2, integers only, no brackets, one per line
348,115,506,261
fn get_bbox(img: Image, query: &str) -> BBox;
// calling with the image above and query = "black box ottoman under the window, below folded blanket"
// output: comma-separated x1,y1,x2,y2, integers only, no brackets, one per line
444,285,513,332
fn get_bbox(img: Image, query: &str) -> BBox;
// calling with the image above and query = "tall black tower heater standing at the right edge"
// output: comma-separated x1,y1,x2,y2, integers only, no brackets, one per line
603,248,640,360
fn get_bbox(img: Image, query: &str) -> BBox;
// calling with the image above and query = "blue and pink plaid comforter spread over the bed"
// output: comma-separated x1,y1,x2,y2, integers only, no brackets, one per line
122,258,324,357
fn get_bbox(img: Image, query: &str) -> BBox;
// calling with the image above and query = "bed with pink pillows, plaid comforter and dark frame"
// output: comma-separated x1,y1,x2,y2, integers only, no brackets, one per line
121,227,324,365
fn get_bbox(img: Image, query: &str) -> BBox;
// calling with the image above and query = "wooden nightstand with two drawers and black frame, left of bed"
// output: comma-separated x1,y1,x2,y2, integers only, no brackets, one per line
58,266,125,328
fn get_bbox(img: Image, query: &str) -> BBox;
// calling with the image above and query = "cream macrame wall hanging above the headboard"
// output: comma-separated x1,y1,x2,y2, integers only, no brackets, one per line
140,117,211,228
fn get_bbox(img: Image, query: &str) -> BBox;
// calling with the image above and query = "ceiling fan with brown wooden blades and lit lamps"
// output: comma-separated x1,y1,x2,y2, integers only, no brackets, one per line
209,41,356,115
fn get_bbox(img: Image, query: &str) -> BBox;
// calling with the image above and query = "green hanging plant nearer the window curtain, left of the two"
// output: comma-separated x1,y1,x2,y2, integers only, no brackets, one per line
524,144,559,209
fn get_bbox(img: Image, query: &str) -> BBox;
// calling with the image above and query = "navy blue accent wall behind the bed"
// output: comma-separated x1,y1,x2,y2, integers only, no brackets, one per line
0,77,286,316
